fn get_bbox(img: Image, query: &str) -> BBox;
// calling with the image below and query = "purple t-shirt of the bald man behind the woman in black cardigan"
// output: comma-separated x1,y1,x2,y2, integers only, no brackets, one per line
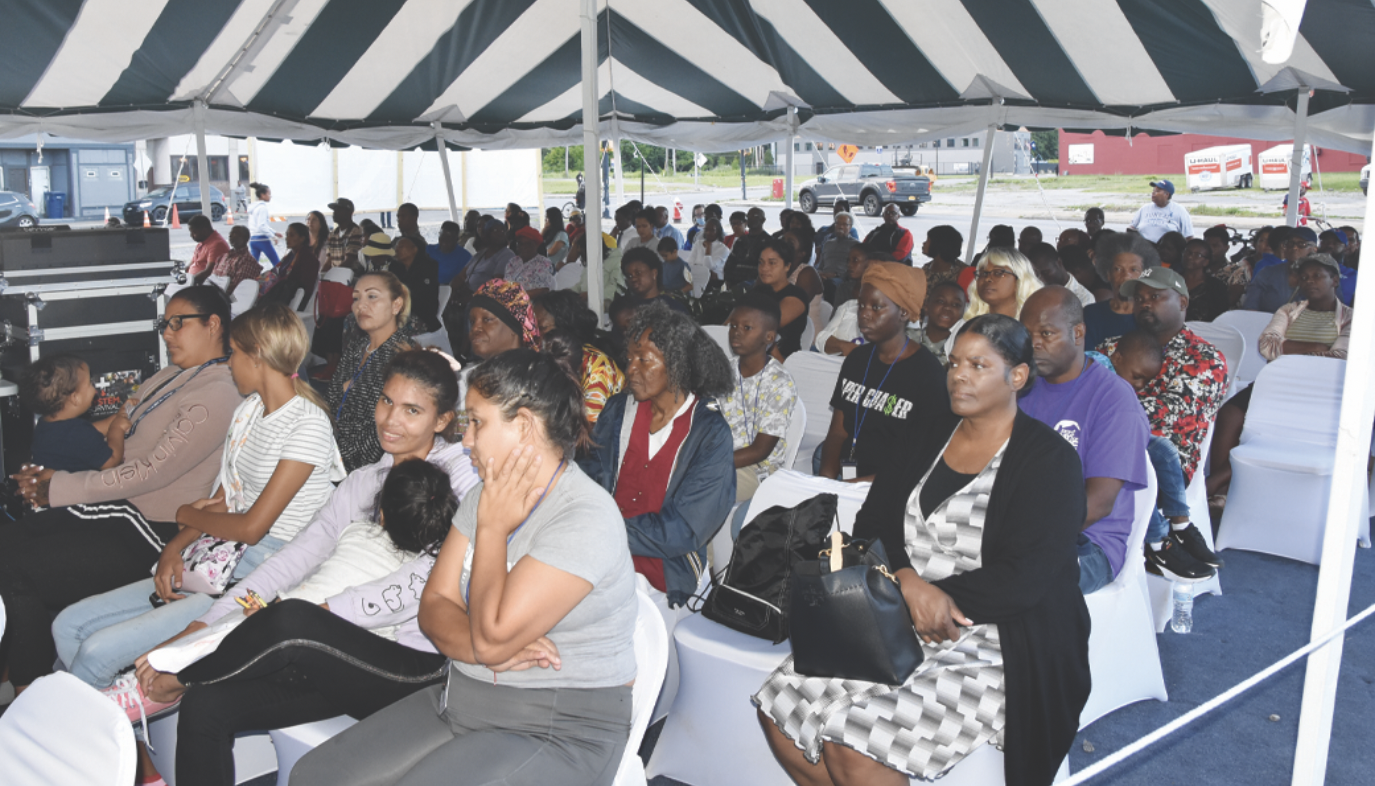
1019,360,1151,576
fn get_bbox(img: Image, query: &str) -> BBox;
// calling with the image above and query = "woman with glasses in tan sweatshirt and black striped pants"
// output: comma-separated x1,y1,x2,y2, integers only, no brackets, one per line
0,286,242,690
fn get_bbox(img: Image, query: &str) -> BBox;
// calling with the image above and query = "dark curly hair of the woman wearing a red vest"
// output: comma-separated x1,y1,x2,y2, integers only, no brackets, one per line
626,304,734,398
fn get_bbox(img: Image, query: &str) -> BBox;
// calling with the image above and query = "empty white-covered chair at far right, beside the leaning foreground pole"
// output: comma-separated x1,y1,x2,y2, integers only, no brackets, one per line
1217,355,1371,565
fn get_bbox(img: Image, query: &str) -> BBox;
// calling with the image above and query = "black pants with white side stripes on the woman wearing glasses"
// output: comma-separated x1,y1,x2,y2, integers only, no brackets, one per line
0,502,177,686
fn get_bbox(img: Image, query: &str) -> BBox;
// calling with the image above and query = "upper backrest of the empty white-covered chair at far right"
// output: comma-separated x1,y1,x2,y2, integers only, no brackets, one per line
1242,355,1346,448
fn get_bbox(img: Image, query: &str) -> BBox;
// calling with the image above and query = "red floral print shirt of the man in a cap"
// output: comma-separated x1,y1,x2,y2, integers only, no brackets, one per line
1099,327,1227,482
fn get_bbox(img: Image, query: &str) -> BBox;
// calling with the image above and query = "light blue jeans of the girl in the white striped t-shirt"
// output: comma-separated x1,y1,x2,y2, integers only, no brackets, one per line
52,536,286,688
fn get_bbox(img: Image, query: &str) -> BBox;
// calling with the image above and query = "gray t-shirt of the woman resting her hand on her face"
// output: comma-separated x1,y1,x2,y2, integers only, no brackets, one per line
454,463,639,688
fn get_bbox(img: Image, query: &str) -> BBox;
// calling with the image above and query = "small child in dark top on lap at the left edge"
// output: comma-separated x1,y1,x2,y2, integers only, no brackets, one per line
19,355,129,473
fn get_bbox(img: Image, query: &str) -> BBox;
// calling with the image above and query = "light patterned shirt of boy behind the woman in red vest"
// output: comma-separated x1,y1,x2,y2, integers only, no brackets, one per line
716,357,798,481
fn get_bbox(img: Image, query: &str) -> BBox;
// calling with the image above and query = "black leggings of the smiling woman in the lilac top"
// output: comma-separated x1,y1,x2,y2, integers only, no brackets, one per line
176,600,447,786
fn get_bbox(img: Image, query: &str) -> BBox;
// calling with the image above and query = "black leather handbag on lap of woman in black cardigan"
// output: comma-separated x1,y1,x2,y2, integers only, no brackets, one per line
791,532,925,686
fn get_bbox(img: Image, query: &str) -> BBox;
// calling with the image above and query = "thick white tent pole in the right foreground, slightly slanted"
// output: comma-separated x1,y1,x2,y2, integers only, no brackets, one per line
1290,122,1375,786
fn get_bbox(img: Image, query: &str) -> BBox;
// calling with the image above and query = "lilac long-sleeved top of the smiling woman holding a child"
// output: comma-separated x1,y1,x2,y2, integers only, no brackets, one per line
199,438,479,653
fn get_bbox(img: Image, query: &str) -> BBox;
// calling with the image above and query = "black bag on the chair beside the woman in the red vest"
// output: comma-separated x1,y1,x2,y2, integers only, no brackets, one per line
701,493,839,644
